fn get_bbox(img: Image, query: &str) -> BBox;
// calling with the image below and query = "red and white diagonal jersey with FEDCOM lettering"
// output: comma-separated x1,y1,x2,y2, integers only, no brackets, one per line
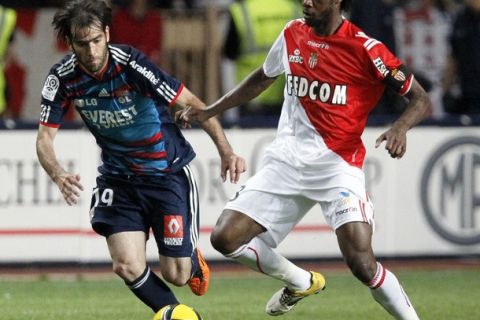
263,19,413,196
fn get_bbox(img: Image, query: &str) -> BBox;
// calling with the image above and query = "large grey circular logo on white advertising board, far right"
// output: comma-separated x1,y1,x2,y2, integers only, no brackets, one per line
420,136,480,245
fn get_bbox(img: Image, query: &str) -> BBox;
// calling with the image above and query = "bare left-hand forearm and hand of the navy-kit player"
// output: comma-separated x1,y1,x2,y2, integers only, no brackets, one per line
36,125,83,205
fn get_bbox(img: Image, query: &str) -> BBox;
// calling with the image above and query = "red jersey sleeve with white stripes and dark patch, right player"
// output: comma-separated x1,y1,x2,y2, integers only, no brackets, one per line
363,38,413,96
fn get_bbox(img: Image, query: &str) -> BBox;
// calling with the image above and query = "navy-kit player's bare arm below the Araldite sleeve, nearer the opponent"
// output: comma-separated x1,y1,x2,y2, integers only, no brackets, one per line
175,88,247,183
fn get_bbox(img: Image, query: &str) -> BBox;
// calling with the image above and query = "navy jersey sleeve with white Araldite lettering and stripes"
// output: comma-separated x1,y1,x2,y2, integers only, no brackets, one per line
128,48,184,106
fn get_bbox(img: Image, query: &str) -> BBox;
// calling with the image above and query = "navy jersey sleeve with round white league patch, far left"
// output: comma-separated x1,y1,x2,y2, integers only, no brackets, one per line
40,66,70,128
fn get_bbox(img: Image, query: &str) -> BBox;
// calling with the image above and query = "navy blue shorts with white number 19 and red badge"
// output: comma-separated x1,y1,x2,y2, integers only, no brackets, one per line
90,166,200,257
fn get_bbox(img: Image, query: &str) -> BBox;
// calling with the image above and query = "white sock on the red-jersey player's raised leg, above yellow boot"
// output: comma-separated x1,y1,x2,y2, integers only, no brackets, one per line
225,237,312,291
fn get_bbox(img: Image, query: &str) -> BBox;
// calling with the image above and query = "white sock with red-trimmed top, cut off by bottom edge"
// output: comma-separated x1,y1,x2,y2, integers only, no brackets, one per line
367,262,419,320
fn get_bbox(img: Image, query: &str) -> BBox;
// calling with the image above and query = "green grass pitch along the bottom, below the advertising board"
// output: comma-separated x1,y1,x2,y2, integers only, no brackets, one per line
0,269,480,320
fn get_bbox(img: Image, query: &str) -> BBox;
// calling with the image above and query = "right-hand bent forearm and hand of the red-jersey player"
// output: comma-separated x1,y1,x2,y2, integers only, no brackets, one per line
375,79,431,159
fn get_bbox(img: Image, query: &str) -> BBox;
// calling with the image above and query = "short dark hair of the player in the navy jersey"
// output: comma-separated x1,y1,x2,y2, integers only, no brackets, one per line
52,0,112,42
